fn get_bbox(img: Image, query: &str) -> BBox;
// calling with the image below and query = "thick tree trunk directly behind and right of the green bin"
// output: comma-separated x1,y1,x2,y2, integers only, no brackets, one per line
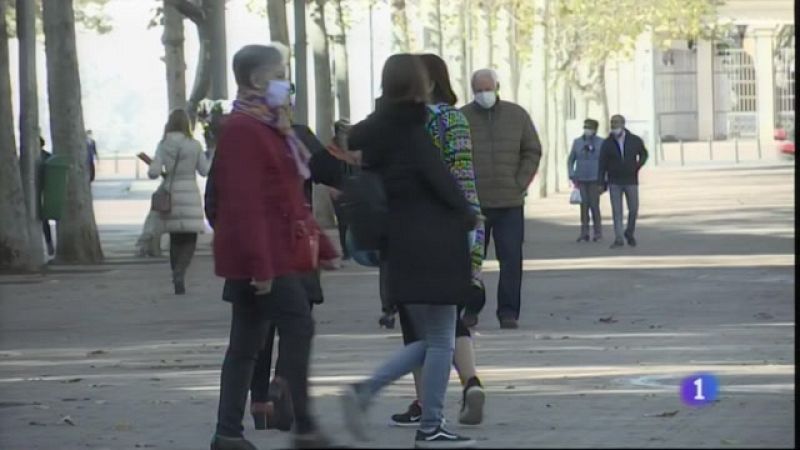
42,0,103,263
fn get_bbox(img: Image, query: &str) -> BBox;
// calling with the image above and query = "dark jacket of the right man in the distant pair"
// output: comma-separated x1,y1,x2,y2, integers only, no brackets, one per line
600,129,647,185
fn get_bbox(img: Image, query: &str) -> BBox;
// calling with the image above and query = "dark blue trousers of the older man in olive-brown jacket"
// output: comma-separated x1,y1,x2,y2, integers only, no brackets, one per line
482,206,525,319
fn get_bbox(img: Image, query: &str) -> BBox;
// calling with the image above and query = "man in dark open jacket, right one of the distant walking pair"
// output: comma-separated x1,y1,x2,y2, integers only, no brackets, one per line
600,115,648,249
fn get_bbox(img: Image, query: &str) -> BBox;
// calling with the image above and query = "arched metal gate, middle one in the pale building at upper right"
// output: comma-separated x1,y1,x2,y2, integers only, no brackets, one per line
714,48,758,139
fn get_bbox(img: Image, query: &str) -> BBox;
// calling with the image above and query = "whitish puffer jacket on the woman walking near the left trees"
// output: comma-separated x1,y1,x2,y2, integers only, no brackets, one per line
147,132,211,233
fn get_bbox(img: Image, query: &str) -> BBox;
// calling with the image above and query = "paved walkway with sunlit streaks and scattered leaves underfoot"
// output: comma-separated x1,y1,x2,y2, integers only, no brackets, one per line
0,164,795,450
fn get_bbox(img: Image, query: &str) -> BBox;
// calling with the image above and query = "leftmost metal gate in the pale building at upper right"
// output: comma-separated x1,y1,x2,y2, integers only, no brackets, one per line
654,49,698,142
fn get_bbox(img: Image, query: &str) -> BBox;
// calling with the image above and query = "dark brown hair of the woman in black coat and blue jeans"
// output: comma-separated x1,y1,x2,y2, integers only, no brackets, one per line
381,53,428,103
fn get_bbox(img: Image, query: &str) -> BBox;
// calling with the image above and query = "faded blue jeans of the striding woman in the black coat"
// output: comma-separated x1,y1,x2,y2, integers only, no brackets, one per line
364,305,456,431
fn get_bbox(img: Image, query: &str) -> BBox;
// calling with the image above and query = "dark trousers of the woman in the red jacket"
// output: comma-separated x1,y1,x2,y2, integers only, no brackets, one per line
217,276,314,437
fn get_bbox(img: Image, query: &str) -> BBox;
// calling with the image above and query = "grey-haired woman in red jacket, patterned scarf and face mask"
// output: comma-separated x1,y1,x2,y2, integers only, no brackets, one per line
211,45,337,450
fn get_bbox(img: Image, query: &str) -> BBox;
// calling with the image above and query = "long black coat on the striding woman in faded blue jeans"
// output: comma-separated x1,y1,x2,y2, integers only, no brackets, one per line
348,103,475,305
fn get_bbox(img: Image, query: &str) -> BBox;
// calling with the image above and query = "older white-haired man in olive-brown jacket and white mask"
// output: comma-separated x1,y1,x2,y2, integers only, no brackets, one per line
461,69,542,328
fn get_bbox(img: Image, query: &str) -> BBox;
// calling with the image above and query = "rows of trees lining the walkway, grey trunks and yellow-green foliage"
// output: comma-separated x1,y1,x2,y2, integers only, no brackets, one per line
0,0,719,269
